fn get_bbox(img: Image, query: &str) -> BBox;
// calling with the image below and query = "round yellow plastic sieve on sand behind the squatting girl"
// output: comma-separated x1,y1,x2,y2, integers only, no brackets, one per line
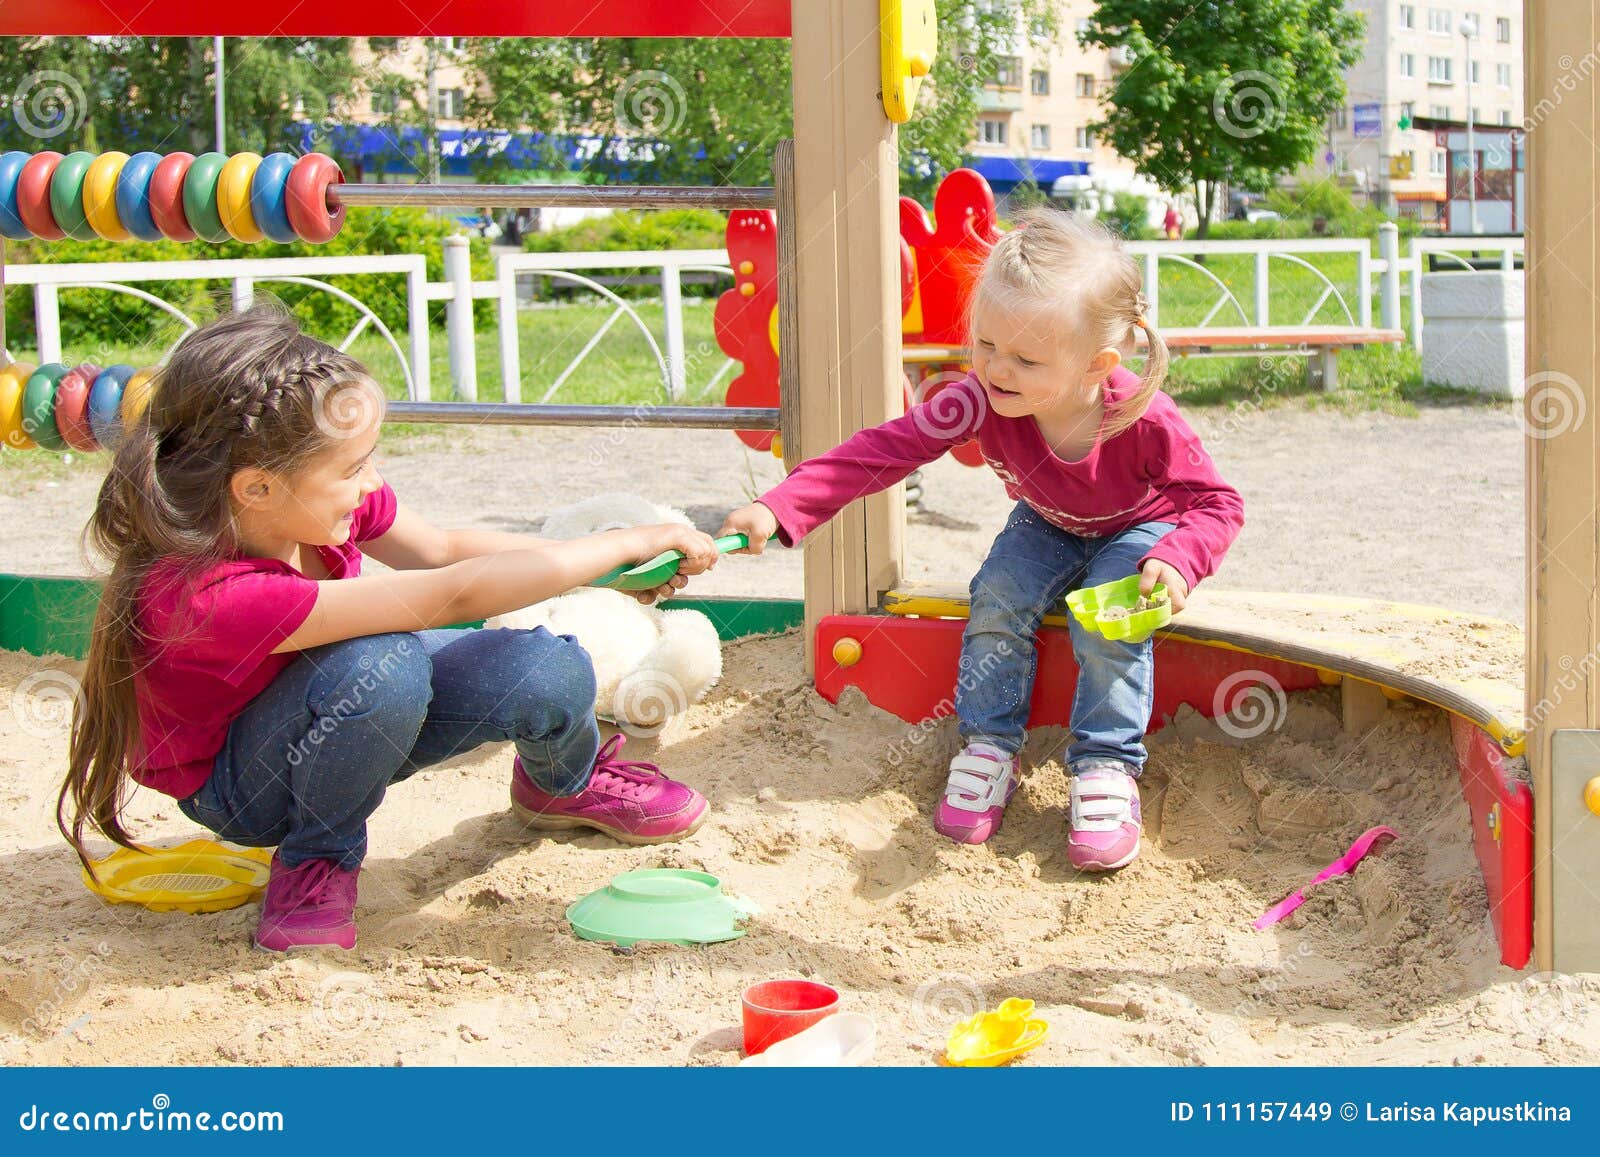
83,840,272,912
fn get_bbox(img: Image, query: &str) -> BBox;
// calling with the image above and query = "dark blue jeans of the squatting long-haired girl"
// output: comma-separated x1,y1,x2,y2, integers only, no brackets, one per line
178,627,600,867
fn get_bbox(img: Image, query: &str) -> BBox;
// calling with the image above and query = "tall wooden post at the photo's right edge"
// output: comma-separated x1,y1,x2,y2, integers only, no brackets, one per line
1523,0,1600,971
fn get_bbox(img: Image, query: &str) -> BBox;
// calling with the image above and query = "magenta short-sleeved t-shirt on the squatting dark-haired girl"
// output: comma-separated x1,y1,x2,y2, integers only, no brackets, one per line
131,482,395,799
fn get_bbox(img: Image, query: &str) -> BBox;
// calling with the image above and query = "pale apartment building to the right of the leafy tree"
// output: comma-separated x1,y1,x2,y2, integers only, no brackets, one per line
1320,0,1525,224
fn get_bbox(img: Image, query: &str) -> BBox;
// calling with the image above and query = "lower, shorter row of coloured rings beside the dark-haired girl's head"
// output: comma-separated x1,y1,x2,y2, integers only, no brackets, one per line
0,362,155,451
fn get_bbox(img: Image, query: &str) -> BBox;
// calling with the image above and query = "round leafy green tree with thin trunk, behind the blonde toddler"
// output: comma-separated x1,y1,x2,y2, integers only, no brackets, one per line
1078,0,1365,238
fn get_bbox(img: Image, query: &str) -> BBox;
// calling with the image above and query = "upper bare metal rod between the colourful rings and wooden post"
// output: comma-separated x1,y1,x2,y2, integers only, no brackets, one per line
328,184,778,210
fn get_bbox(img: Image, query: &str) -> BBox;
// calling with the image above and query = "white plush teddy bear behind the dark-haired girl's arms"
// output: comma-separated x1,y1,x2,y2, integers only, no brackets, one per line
488,494,722,735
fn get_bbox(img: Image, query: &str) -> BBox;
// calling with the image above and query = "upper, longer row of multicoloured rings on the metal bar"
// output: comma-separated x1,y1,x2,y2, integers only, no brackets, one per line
0,152,344,245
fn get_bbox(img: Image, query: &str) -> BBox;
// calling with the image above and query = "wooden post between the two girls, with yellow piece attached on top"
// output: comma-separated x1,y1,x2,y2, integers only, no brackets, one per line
784,0,906,672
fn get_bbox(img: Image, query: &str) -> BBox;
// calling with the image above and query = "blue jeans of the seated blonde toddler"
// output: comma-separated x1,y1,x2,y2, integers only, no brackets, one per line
955,502,1173,775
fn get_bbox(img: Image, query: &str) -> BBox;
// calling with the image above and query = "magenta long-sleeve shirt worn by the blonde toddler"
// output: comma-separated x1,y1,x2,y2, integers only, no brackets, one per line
758,366,1245,591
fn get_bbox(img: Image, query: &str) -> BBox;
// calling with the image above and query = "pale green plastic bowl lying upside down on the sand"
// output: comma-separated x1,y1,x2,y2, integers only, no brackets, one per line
566,867,749,947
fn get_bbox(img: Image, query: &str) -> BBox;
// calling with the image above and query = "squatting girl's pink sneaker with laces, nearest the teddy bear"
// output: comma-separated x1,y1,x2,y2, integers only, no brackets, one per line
510,735,709,843
